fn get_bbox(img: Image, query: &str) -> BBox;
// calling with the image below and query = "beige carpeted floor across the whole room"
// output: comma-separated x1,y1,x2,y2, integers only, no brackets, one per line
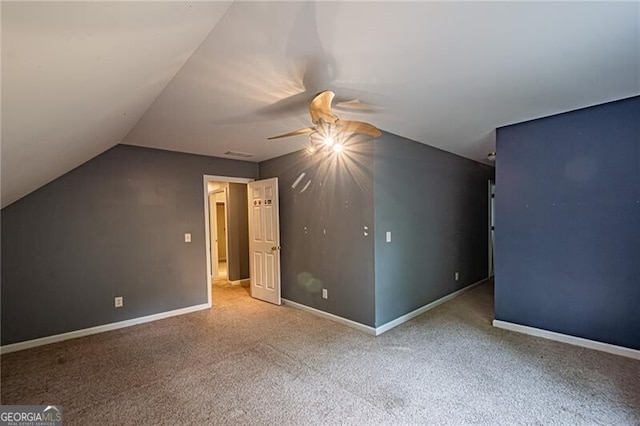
1,284,640,425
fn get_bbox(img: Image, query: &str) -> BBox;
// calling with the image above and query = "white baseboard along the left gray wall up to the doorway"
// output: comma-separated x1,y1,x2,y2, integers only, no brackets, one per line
0,303,211,354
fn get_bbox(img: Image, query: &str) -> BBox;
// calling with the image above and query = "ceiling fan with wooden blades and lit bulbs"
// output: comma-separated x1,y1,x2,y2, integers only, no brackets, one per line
267,90,382,153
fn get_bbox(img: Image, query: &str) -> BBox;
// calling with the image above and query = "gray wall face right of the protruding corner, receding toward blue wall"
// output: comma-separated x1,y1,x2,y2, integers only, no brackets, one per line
374,133,494,326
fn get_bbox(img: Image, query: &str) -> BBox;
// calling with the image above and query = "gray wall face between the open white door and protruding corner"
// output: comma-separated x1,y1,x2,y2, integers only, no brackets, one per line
260,142,375,326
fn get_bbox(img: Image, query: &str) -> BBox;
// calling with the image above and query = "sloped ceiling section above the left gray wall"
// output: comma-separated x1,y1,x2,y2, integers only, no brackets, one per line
2,1,231,207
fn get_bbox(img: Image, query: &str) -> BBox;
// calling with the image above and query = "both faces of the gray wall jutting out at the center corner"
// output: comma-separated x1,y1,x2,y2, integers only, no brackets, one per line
260,133,494,327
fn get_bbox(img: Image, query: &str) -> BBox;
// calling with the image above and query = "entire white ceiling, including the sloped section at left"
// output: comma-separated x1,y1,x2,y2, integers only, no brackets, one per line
2,1,640,206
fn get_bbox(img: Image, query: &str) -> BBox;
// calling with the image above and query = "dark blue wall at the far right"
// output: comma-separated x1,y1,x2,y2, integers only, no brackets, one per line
495,97,640,349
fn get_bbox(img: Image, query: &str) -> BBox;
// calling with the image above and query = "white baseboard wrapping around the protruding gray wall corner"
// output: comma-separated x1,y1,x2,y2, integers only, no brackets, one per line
282,278,487,336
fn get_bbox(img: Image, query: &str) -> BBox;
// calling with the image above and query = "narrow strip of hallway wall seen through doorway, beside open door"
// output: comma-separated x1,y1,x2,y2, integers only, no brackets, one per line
227,183,249,281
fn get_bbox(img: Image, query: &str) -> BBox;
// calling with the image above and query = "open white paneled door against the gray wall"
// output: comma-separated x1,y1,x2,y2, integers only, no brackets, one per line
248,178,281,305
